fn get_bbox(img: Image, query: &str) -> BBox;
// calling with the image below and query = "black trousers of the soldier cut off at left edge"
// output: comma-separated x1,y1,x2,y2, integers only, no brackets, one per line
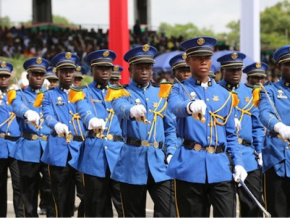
0,157,24,217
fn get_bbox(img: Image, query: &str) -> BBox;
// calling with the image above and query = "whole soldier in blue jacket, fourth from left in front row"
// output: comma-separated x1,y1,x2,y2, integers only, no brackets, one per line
70,50,124,217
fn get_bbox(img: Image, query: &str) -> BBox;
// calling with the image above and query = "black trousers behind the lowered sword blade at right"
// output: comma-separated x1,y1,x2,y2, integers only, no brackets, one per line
238,169,264,217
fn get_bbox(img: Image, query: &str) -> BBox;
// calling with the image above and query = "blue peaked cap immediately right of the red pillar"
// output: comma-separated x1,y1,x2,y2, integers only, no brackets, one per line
124,44,157,64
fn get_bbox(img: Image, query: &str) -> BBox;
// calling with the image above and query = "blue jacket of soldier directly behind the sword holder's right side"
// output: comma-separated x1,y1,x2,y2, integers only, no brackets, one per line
219,80,265,172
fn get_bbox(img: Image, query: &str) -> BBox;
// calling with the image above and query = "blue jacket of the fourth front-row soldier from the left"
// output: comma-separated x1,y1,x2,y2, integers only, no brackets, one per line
69,82,124,178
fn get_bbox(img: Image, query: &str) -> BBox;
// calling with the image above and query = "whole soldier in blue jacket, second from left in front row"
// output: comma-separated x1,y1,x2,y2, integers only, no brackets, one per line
8,57,55,217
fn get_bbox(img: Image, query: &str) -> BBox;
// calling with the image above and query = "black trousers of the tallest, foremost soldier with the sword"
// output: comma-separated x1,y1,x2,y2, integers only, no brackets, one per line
175,180,236,217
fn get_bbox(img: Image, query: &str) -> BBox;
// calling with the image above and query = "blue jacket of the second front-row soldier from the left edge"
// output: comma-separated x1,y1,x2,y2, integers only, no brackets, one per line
11,86,50,163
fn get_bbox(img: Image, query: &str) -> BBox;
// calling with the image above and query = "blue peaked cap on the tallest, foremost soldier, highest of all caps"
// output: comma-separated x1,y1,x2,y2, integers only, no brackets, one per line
180,37,217,57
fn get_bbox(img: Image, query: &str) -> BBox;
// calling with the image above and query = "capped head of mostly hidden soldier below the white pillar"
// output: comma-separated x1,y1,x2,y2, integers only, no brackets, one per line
243,62,268,89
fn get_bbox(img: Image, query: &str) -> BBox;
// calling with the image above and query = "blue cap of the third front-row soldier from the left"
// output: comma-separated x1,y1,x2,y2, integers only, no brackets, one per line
50,52,80,70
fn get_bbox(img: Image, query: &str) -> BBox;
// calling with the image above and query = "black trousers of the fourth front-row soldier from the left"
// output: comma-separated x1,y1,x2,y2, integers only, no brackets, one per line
84,170,123,217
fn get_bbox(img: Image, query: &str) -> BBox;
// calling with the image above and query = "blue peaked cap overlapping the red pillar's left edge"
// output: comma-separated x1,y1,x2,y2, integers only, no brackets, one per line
85,49,116,66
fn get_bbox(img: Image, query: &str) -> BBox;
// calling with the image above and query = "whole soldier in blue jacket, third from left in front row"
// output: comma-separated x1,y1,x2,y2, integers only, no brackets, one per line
41,52,85,217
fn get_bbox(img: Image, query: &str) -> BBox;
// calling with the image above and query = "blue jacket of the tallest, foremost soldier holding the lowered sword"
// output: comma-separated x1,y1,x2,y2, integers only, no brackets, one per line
167,77,244,184
